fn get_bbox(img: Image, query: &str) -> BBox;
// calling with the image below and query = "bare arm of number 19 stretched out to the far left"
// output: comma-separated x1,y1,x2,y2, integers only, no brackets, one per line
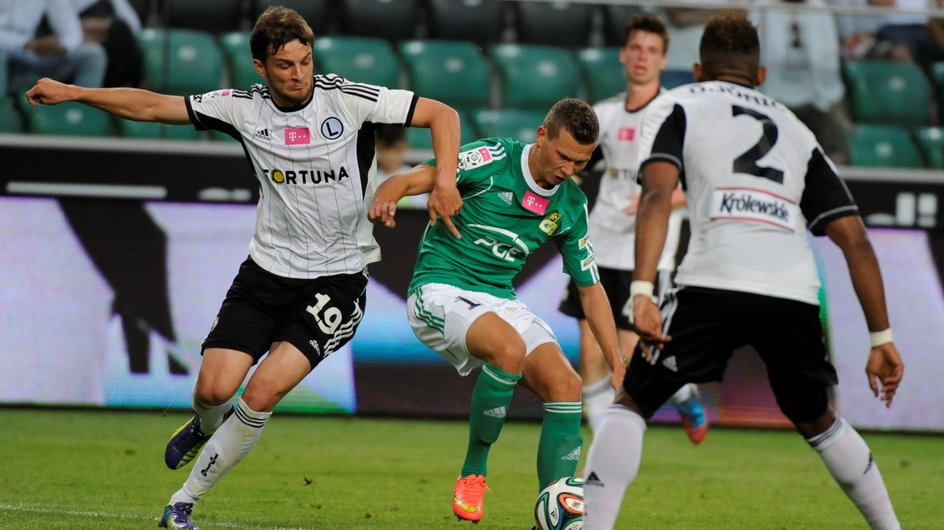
26,77,190,125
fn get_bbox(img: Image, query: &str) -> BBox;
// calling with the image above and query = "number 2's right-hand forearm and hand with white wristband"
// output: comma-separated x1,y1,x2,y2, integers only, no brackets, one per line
826,212,905,407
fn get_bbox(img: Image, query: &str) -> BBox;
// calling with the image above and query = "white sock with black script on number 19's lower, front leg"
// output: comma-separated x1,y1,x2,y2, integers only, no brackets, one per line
169,399,272,504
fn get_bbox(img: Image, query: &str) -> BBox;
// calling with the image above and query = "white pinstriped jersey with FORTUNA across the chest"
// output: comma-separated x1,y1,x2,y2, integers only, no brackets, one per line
187,74,417,279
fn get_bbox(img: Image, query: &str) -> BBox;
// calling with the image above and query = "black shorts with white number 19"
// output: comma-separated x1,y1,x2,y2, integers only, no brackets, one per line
203,258,367,368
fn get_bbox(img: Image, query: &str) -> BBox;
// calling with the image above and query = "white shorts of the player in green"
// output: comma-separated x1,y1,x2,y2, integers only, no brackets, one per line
406,283,557,375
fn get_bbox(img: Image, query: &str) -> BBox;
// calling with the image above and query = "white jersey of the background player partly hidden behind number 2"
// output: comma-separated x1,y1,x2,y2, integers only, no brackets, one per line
590,92,682,270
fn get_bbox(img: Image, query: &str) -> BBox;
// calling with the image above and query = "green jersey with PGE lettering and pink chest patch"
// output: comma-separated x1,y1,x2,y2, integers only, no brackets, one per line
409,138,600,298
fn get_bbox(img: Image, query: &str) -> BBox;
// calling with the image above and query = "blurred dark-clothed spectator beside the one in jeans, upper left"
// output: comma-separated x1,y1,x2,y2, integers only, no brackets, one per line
72,0,142,87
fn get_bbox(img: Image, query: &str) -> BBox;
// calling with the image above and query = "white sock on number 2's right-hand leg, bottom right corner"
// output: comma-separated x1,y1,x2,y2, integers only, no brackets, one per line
804,418,901,530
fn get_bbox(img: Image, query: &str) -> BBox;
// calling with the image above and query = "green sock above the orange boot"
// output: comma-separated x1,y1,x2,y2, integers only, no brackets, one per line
460,364,521,477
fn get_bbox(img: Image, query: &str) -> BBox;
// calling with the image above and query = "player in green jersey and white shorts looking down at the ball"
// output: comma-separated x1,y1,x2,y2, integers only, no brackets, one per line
369,99,625,522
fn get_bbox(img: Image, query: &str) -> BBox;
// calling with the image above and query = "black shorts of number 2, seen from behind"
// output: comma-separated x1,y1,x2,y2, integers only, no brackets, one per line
623,287,838,423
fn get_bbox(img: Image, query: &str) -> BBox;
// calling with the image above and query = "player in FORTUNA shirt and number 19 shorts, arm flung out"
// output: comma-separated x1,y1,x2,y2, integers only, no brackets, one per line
26,7,462,528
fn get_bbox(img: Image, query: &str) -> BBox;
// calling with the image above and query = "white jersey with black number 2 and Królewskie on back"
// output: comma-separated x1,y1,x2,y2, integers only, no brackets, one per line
640,81,858,304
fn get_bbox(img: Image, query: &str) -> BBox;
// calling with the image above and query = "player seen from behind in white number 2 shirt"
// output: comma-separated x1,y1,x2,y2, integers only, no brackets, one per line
584,10,904,530
